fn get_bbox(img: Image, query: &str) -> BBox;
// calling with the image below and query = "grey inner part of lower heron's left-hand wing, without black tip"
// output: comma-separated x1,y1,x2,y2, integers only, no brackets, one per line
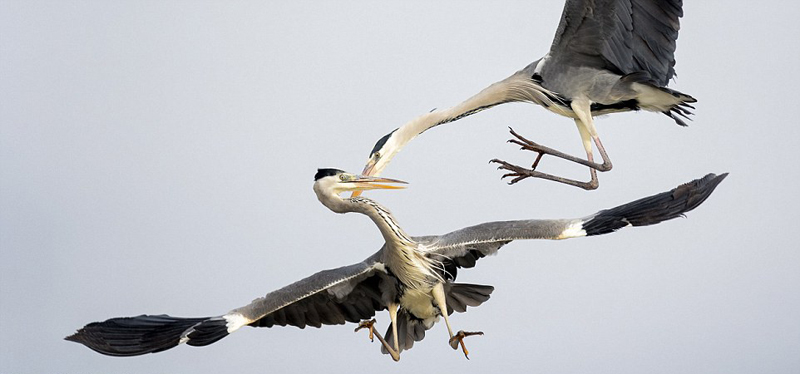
225,254,393,330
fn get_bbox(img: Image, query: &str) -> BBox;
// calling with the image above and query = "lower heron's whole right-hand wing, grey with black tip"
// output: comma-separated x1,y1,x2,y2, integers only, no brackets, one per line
416,173,728,272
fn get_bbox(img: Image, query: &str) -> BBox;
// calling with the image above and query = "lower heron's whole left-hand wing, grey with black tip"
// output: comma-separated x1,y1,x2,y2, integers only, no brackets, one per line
66,252,396,356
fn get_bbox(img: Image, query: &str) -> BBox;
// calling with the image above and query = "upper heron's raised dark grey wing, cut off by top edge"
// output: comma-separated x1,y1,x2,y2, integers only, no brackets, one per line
550,0,683,86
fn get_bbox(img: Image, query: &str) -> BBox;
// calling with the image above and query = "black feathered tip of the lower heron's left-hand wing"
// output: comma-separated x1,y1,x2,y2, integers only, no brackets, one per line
65,314,228,356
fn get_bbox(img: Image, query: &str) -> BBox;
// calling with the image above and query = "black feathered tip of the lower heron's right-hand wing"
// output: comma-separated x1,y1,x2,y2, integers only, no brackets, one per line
583,173,728,236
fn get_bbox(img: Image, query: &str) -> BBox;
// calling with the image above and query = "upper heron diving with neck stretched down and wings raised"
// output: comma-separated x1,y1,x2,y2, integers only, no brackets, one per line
363,0,696,189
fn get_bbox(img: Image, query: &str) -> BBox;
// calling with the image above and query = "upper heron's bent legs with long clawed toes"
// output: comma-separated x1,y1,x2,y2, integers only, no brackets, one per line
489,100,612,190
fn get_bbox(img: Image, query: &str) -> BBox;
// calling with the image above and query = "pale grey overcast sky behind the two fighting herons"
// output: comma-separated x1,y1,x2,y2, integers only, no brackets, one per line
0,0,800,374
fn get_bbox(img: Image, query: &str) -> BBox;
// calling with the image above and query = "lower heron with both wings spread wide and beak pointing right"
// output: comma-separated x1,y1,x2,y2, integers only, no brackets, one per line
66,169,727,360
